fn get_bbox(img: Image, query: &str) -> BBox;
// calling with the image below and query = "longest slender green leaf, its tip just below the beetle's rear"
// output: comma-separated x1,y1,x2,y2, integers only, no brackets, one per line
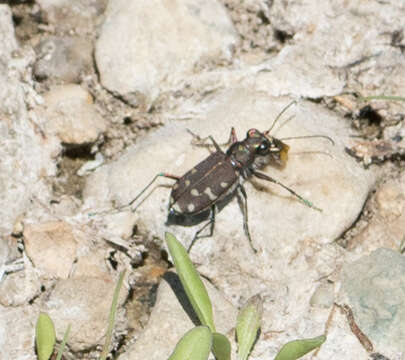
165,232,215,333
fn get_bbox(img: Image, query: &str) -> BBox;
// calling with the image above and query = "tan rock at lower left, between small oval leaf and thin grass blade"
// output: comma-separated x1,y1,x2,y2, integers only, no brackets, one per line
43,277,126,352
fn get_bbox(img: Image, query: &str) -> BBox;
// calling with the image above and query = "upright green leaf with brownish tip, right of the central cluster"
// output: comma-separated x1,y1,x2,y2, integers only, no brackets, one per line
236,295,263,360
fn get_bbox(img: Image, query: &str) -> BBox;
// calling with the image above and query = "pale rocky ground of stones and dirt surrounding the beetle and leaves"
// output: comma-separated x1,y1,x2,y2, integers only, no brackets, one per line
0,0,405,360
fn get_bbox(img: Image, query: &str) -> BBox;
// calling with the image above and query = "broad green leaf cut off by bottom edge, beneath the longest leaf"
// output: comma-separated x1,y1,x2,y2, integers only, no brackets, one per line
168,326,212,360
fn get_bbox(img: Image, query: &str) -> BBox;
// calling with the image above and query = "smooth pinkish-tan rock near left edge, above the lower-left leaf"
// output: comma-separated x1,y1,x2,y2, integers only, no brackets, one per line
24,221,77,279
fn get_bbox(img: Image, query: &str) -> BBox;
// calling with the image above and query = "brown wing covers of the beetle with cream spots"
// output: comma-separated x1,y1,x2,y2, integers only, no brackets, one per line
169,151,239,215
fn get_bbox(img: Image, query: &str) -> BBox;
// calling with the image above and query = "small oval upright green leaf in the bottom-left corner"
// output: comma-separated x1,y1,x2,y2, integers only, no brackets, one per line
35,313,56,360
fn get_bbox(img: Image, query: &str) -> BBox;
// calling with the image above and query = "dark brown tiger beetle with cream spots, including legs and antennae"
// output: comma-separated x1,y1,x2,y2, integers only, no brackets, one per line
118,102,333,253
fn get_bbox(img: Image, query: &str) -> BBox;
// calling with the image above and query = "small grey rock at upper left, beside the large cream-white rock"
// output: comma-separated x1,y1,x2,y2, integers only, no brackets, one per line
34,36,93,83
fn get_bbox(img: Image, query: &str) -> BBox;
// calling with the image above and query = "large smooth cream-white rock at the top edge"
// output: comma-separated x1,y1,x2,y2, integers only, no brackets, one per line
96,0,238,106
